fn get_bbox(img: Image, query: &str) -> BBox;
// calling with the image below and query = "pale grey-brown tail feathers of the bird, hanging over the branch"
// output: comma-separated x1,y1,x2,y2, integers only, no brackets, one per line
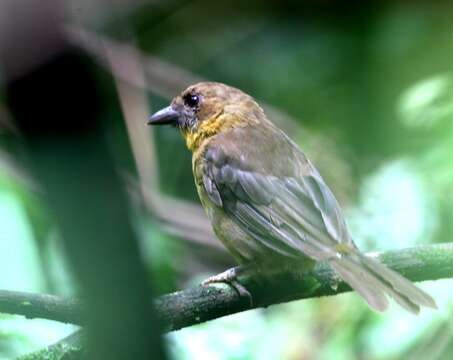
329,252,437,314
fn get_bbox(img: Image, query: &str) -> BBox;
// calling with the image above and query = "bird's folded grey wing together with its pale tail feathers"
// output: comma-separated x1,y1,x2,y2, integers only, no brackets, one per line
201,135,436,313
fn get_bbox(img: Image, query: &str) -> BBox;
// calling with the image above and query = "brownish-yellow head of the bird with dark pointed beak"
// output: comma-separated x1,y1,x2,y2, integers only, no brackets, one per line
148,82,263,151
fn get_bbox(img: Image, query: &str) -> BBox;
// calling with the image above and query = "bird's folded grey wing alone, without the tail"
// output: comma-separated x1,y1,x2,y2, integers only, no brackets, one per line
201,135,353,260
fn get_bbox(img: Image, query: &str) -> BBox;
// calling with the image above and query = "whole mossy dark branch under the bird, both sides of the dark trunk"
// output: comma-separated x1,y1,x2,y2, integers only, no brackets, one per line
0,243,453,331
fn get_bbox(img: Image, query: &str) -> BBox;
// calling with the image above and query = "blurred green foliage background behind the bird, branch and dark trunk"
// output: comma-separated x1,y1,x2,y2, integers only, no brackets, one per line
0,0,453,359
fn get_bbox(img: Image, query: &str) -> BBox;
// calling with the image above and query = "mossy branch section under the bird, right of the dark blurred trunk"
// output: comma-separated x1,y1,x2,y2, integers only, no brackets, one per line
156,243,453,331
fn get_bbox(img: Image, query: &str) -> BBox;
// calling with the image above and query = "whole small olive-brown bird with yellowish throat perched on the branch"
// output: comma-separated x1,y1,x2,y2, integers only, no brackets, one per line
148,82,436,313
